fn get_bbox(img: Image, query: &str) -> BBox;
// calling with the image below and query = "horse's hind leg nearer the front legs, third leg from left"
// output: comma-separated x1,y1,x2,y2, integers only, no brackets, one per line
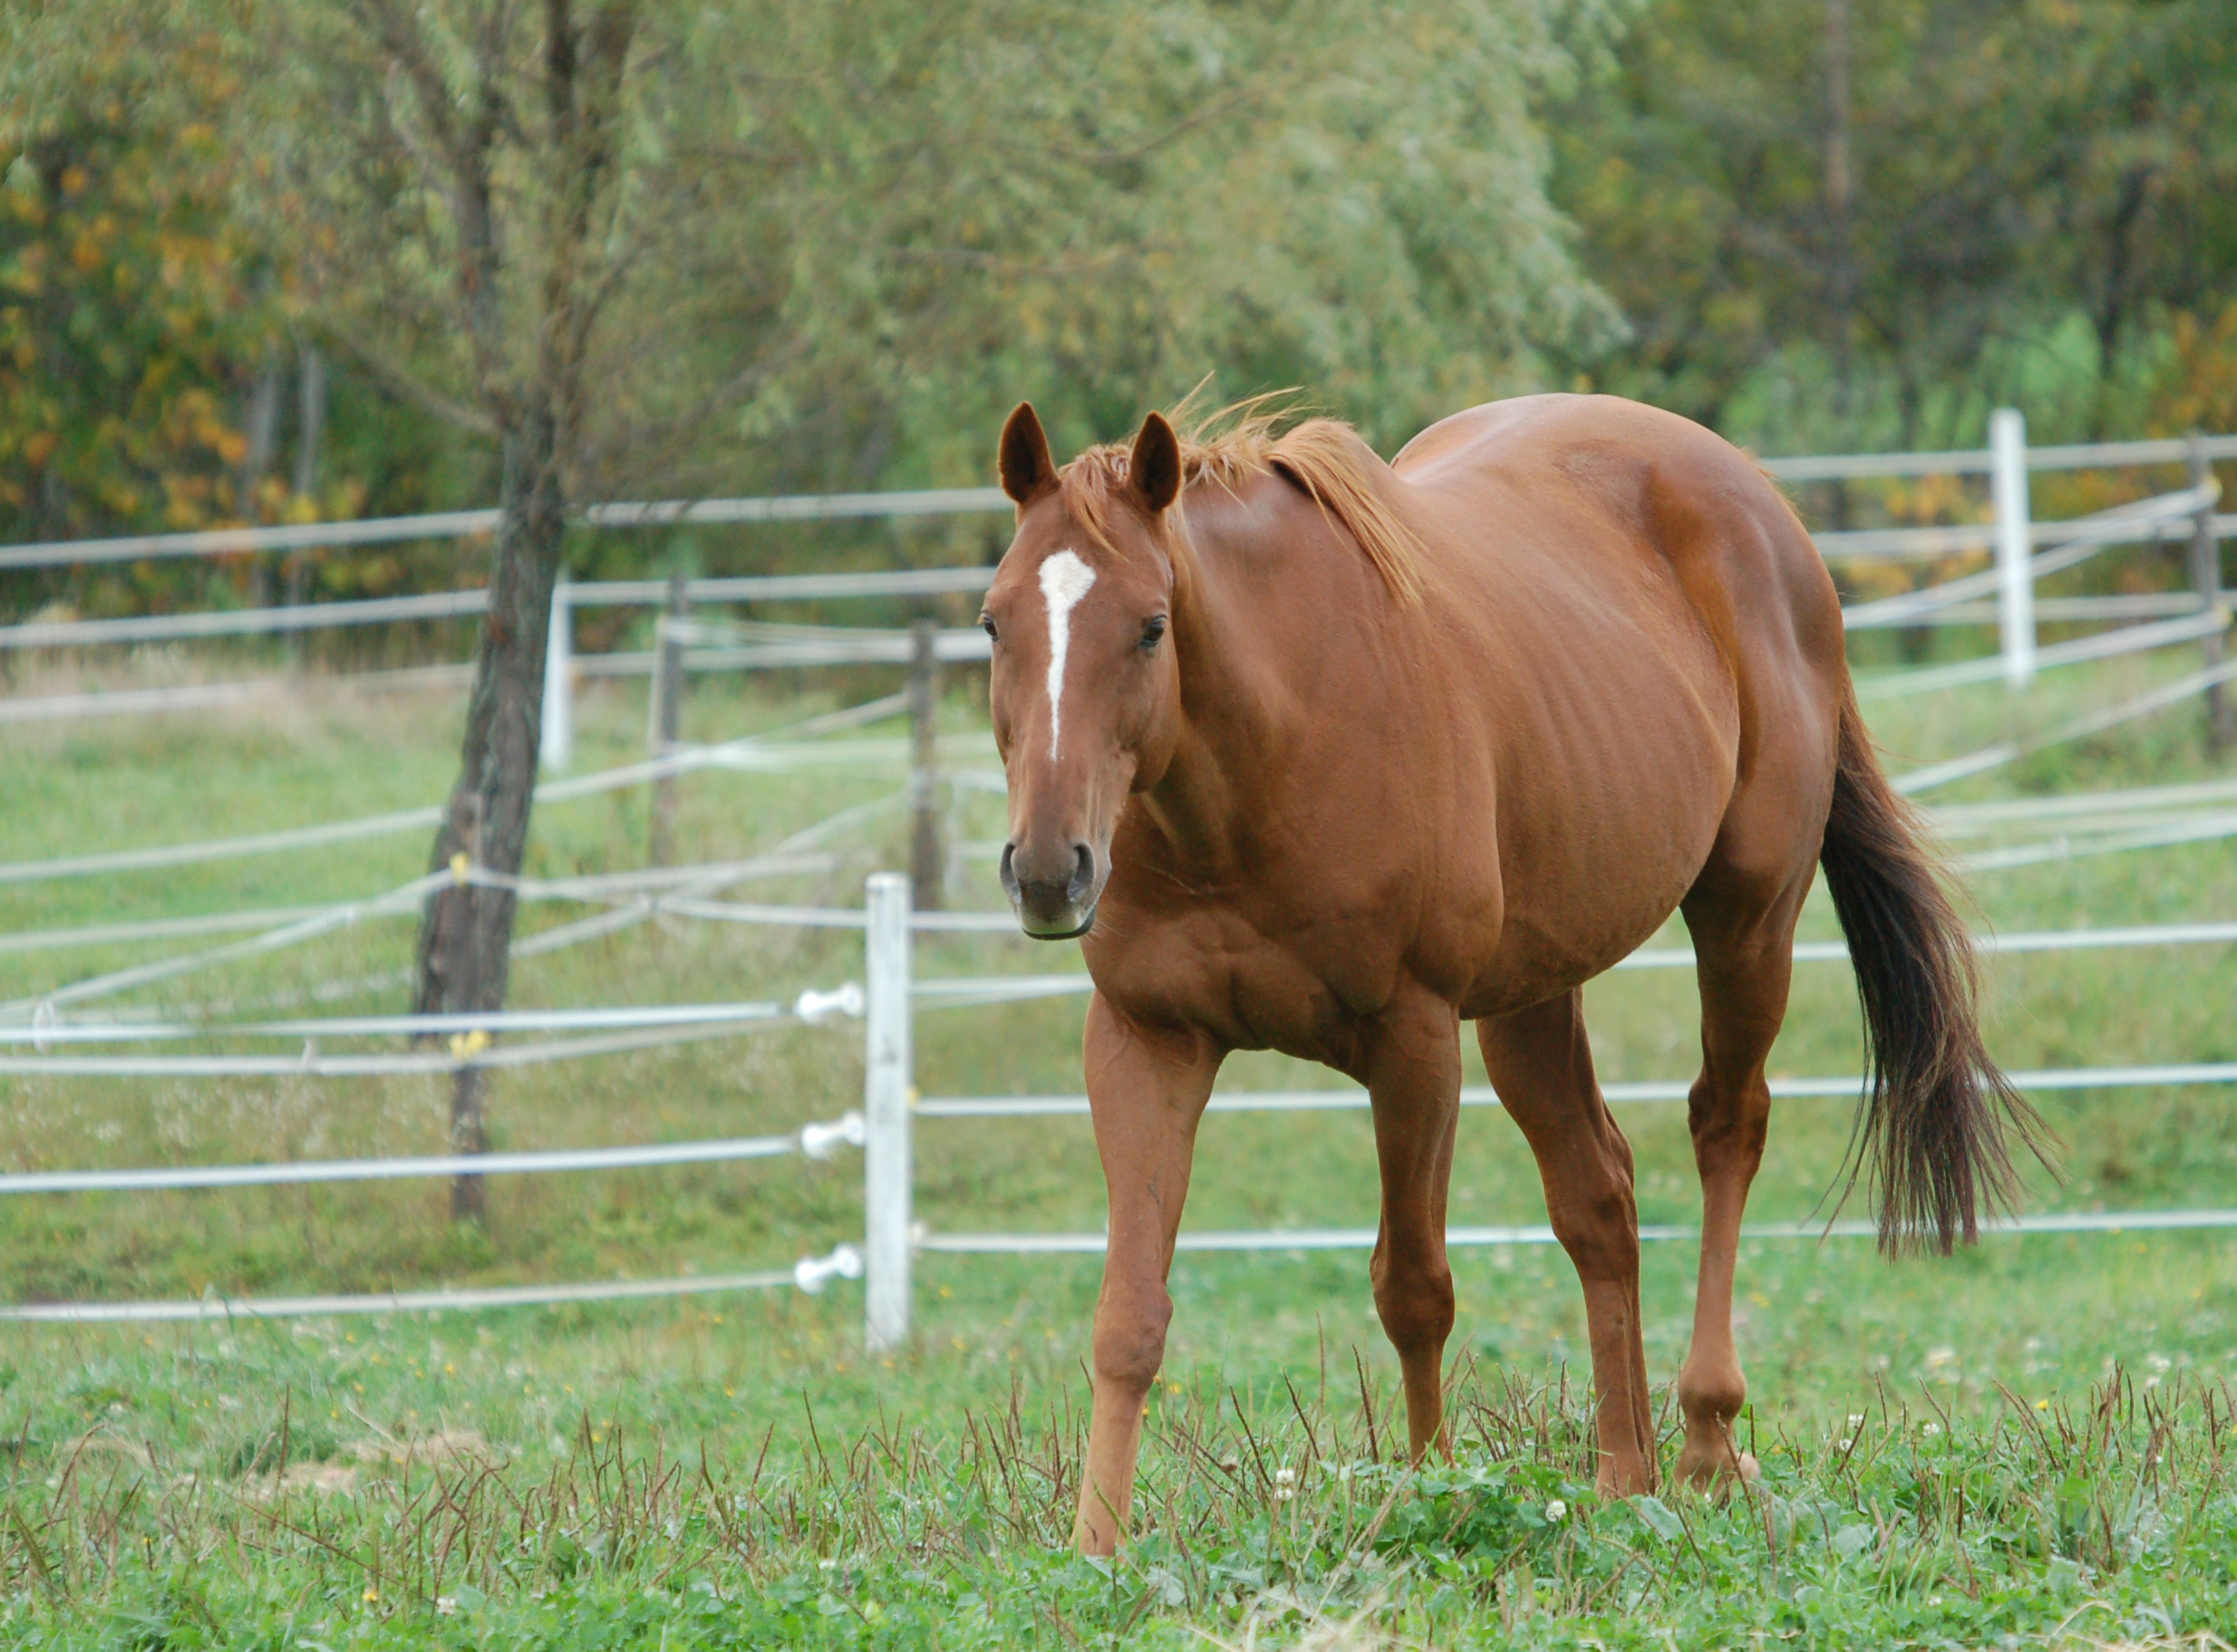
1477,992,1655,1498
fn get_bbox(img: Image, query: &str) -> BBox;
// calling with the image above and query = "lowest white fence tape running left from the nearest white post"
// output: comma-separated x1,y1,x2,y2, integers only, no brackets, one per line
0,1245,861,1326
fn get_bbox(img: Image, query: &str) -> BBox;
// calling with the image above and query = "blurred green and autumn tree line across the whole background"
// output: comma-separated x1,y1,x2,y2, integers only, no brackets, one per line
0,0,2237,614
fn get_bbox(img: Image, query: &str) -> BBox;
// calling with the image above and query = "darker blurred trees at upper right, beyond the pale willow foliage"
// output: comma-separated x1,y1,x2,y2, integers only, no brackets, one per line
1550,0,2237,451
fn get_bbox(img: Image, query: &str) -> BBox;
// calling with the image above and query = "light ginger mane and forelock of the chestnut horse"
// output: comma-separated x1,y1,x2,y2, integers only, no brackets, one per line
1058,393,1420,604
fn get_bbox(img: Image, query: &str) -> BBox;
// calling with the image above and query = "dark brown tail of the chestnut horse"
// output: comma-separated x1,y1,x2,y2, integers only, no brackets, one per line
1821,691,2045,1254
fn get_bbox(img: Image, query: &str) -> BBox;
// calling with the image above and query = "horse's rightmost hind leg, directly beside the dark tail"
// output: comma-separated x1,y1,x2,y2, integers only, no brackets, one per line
1678,863,1810,1489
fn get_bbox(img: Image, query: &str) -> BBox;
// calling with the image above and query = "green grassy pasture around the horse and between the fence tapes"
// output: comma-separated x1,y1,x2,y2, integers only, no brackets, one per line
0,639,2237,1647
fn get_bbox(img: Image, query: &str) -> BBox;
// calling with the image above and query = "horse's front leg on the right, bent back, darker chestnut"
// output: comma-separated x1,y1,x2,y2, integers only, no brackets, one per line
1367,992,1461,1462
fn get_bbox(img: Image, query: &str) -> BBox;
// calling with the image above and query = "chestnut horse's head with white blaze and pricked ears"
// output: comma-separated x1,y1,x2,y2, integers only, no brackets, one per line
980,402,1181,942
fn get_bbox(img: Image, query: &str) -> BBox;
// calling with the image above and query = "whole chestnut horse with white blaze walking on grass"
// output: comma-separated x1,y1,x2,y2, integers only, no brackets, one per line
984,396,2033,1553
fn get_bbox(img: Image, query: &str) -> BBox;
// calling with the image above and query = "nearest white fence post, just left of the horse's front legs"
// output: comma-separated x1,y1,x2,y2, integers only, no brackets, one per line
861,872,915,1352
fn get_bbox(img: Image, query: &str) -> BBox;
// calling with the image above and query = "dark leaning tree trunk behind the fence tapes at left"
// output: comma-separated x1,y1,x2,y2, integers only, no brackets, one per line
412,398,566,1218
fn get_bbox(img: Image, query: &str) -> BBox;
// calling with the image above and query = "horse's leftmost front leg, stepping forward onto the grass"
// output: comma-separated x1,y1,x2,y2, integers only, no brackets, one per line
1071,992,1224,1553
